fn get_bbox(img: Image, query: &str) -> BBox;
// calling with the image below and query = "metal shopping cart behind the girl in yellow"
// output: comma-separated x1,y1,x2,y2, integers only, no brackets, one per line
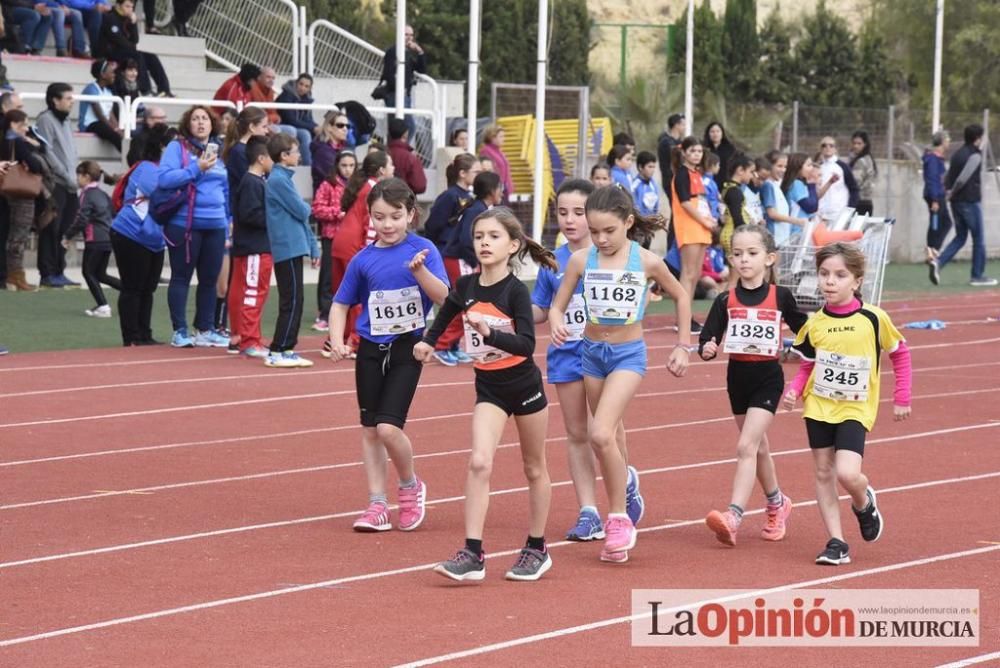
777,213,896,311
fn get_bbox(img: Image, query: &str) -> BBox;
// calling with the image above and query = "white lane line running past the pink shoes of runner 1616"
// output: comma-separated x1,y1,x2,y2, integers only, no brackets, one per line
0,422,1000,569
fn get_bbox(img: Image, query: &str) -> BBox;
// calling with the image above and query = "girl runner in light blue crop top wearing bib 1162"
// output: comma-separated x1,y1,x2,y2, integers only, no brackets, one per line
549,186,691,562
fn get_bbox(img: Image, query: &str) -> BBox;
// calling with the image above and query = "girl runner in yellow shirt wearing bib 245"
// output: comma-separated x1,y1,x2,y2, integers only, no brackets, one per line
784,242,912,566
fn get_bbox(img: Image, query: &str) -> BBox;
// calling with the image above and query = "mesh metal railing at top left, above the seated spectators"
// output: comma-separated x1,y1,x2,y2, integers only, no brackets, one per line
156,0,305,76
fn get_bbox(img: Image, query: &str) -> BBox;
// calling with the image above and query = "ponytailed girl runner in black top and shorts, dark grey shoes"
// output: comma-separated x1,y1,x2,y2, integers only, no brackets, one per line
413,207,557,580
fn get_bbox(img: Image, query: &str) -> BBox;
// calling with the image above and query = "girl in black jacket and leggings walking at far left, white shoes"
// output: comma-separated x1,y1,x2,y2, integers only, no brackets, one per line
62,160,122,318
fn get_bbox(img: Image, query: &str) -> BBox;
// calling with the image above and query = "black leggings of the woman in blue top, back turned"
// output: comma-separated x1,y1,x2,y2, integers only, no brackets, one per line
111,230,164,346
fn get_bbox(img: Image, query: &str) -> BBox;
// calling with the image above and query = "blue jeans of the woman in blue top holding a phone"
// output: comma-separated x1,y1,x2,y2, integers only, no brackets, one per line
163,224,226,334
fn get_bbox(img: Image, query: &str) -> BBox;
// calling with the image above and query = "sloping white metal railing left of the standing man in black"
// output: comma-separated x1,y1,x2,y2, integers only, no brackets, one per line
305,19,445,164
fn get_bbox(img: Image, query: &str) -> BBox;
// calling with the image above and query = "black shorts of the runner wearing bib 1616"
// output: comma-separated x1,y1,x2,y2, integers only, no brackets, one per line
354,336,424,429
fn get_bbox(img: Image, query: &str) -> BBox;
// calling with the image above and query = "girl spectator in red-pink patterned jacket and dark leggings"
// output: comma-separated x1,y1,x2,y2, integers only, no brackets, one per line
312,149,358,332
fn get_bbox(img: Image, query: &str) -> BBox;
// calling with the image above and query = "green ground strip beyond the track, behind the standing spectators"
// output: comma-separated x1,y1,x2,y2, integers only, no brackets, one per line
0,260,1000,352
